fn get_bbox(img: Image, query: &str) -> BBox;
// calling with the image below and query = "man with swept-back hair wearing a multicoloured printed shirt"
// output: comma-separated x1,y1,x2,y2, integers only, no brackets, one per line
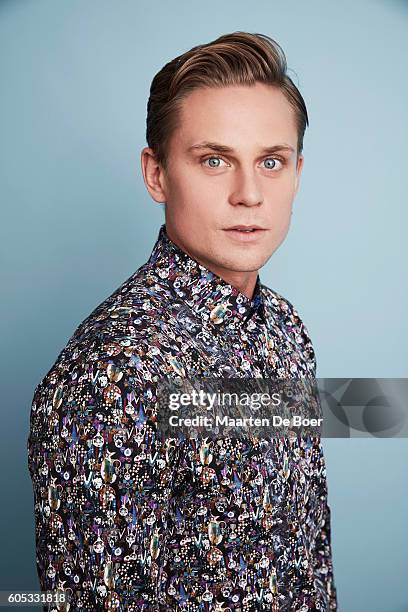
28,32,337,612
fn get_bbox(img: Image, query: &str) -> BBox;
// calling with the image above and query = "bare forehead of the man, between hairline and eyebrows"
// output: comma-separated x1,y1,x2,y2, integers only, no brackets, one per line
174,83,297,147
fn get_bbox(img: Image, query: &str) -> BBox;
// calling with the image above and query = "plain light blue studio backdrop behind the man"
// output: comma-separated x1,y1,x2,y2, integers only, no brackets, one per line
0,0,408,612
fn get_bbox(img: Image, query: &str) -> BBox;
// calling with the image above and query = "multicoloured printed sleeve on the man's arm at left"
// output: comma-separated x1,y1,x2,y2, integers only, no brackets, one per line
27,347,178,610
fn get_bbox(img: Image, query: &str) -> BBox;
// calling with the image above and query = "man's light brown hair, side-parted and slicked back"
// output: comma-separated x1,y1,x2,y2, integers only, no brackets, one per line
146,32,309,169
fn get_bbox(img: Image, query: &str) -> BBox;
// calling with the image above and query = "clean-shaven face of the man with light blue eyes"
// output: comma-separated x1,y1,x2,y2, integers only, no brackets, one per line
143,83,303,289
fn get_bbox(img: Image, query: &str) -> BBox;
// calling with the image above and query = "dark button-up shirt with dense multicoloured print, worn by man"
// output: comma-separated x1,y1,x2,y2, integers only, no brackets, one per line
27,225,337,612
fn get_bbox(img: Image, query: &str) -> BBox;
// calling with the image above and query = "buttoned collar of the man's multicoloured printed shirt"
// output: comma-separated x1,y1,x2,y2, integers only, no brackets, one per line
147,224,265,328
